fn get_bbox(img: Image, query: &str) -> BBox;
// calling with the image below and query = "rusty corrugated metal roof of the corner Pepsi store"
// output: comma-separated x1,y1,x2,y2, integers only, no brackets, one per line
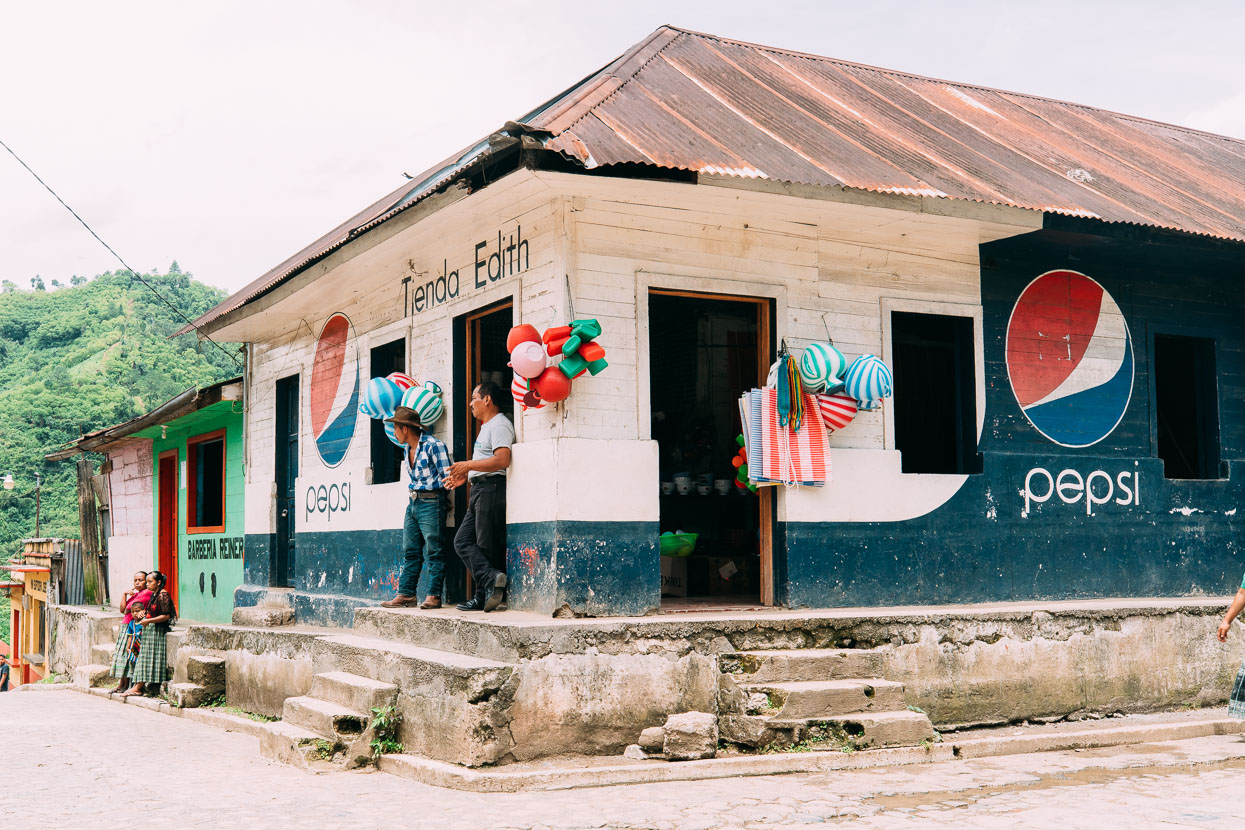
178,26,1245,333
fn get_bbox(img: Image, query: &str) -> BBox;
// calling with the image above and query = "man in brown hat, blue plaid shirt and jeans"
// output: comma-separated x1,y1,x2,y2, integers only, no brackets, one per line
381,407,452,609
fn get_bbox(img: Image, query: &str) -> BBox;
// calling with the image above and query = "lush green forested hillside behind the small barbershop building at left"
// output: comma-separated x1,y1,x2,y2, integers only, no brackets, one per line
0,270,242,640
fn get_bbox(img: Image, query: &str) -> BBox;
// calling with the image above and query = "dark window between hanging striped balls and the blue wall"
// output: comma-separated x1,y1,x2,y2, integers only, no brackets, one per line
890,311,981,474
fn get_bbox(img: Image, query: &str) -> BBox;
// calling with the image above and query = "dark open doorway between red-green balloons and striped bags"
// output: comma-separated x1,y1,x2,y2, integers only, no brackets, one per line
649,290,773,609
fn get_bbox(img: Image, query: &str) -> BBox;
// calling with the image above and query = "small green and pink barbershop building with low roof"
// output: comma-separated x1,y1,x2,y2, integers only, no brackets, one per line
47,378,243,622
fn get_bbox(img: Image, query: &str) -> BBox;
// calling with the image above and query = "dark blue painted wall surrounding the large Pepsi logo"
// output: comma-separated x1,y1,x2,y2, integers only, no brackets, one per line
774,227,1245,607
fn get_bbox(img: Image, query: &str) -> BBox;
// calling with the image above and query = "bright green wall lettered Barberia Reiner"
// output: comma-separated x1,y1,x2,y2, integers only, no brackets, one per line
139,401,244,622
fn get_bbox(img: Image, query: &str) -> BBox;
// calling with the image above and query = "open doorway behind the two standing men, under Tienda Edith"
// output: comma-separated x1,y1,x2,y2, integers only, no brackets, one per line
446,299,514,602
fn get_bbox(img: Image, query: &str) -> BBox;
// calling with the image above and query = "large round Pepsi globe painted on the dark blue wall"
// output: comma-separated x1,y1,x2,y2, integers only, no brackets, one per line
1006,270,1133,447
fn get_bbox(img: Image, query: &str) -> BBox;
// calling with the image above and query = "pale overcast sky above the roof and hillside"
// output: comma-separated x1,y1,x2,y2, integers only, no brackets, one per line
0,0,1245,291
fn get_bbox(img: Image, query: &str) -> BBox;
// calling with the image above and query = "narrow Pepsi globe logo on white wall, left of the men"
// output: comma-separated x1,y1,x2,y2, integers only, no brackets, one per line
308,312,359,467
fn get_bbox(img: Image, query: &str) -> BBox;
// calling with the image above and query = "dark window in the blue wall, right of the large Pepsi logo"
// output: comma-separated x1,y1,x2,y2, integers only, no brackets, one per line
1153,335,1219,479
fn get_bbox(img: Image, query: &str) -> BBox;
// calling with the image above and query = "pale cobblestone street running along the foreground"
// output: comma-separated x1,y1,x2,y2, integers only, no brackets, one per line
0,691,1245,830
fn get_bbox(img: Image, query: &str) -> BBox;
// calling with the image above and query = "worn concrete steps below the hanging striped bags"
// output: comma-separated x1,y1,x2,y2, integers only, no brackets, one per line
718,648,936,749
